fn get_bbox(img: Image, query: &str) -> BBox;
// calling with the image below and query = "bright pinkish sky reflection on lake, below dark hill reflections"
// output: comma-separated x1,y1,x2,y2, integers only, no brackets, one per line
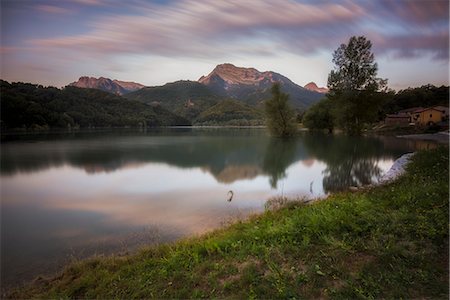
1,164,271,283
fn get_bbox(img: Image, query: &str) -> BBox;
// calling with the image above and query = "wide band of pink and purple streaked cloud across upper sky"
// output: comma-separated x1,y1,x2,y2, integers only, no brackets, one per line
30,0,448,59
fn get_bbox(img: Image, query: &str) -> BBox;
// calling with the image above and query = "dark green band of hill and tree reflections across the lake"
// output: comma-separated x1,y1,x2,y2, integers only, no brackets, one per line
1,129,432,192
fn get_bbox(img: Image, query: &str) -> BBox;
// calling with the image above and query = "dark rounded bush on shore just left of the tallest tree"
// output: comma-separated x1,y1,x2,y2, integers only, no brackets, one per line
303,98,334,133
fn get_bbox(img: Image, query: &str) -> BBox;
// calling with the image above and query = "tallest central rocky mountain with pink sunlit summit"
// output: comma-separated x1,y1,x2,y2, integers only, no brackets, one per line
198,64,324,109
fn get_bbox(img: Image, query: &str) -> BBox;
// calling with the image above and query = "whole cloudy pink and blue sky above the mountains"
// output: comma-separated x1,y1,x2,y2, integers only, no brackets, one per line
0,0,449,90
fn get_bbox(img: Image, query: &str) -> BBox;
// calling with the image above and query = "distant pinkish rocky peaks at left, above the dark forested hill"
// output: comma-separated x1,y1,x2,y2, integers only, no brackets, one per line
69,76,144,95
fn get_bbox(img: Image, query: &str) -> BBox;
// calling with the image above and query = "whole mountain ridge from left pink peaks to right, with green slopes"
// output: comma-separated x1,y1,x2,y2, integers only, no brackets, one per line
69,63,324,123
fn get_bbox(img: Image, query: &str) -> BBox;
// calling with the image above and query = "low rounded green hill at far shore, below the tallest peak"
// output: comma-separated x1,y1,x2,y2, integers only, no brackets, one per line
194,100,264,126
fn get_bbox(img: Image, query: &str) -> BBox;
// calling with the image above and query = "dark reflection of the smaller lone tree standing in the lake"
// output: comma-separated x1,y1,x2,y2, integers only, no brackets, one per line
263,138,297,188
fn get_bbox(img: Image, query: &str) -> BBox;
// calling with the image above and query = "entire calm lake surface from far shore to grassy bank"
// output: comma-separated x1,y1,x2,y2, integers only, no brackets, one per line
1,128,433,287
